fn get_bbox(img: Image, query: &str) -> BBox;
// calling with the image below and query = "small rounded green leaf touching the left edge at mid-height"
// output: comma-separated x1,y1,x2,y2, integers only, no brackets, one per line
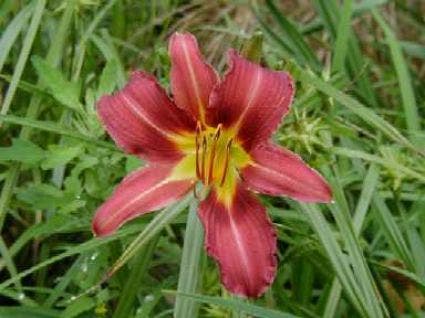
0,138,45,165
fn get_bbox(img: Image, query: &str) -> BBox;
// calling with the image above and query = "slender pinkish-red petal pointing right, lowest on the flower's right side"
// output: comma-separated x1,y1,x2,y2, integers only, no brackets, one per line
241,144,332,202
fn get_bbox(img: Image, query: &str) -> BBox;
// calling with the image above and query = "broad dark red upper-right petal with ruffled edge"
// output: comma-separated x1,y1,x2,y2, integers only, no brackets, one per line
207,50,294,150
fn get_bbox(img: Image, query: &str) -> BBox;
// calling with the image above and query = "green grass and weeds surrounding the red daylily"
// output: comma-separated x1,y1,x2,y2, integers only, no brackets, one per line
0,0,425,318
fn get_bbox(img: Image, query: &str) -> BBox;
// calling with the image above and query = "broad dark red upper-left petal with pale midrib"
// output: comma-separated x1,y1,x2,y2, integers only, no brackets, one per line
98,72,196,162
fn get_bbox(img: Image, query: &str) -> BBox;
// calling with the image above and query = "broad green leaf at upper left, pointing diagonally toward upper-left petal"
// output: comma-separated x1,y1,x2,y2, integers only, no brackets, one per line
31,56,82,111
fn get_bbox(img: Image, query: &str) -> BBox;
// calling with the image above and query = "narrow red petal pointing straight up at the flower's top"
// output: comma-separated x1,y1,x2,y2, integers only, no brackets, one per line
169,33,218,122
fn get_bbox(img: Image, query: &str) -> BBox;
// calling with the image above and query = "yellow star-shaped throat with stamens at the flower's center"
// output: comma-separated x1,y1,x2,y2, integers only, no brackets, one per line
170,123,251,203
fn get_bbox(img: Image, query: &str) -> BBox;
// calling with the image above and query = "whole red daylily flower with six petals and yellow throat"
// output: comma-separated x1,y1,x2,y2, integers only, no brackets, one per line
93,33,332,297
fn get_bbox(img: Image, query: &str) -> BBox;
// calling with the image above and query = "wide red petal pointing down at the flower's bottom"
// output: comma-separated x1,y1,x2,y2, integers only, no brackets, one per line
199,185,277,297
